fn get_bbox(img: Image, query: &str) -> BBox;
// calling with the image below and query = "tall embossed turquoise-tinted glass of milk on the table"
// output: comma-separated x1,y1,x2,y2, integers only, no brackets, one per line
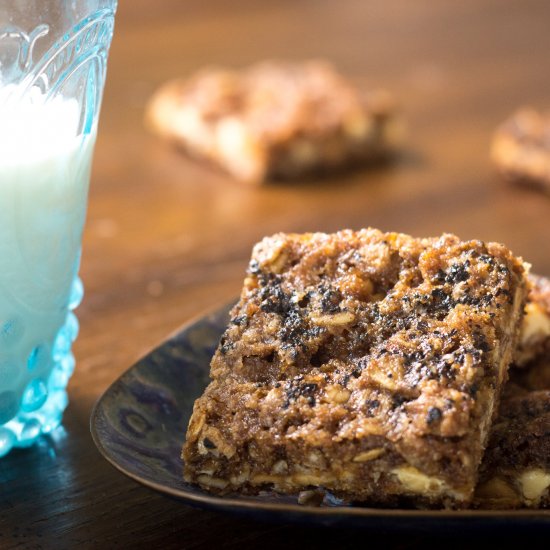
0,0,116,456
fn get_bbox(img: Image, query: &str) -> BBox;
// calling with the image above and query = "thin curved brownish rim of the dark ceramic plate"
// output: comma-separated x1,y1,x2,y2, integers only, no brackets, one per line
90,300,550,524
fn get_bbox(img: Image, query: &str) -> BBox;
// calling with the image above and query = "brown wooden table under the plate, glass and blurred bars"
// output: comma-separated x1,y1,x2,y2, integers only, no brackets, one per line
0,0,550,549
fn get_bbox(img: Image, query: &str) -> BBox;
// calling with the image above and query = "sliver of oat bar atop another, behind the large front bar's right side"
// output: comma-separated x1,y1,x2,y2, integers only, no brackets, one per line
514,274,550,367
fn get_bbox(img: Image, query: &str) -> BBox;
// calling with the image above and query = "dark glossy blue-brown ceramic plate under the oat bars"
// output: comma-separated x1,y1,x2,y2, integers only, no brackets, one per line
91,306,550,531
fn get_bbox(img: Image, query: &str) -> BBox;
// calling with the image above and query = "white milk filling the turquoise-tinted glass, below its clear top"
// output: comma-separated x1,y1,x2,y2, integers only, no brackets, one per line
0,85,95,448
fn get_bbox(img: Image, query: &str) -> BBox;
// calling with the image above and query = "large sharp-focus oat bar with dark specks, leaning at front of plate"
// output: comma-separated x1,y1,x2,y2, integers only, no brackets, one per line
182,229,527,507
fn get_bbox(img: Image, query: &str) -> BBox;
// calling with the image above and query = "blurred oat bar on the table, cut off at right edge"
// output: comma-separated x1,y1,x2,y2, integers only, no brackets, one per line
491,109,550,193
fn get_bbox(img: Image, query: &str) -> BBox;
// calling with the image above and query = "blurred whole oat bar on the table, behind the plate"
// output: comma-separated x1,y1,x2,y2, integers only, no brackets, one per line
147,61,401,183
